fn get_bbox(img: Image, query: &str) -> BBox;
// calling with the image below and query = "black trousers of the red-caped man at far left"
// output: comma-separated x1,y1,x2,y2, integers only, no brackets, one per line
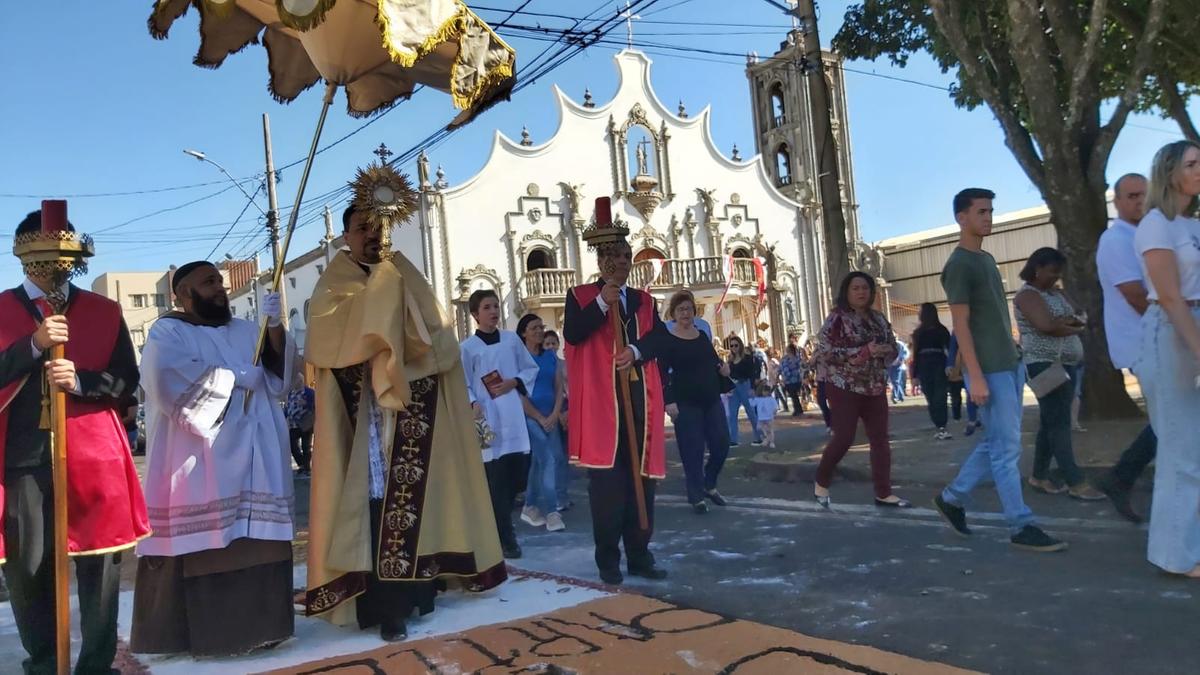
4,466,121,675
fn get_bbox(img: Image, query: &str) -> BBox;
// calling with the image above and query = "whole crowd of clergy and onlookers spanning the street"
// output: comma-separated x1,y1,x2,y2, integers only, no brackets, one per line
0,142,1200,671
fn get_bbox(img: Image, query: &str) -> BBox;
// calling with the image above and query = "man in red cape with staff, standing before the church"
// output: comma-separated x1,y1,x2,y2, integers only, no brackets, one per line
563,197,667,584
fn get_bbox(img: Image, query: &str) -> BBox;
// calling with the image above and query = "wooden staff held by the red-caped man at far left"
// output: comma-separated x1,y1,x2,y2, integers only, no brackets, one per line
47,345,71,675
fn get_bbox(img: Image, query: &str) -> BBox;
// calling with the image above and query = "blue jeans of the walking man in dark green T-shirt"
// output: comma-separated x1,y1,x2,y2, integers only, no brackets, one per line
942,365,1033,534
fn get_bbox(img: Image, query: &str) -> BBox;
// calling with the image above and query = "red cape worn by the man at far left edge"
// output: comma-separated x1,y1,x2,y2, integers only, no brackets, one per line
0,289,150,561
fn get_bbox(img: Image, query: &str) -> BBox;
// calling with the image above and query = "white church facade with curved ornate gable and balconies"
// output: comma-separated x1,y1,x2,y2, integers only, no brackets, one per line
230,49,857,345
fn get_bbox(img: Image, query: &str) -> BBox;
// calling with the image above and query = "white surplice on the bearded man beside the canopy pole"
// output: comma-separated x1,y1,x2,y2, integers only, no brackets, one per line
138,317,296,556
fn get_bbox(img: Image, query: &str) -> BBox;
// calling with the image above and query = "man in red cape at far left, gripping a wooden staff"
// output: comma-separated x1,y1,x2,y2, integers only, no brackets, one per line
0,211,150,673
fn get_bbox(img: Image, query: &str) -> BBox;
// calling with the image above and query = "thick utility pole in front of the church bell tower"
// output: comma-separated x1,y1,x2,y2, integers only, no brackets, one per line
790,0,850,288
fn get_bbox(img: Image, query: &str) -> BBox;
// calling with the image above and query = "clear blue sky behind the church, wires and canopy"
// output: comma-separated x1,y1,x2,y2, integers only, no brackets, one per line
0,0,1200,285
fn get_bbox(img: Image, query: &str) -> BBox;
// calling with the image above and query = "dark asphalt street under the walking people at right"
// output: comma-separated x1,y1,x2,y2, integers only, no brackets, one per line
514,405,1200,673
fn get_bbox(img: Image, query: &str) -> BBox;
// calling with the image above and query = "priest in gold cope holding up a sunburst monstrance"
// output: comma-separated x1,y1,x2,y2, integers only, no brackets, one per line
305,182,506,641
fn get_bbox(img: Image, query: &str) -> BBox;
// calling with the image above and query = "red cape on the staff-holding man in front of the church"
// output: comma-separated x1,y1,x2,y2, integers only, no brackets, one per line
565,283,667,478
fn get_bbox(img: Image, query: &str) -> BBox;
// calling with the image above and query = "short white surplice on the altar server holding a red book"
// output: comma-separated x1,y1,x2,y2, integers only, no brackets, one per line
461,330,538,461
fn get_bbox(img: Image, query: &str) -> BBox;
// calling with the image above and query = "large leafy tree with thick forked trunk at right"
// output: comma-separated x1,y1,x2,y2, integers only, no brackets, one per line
833,0,1180,416
